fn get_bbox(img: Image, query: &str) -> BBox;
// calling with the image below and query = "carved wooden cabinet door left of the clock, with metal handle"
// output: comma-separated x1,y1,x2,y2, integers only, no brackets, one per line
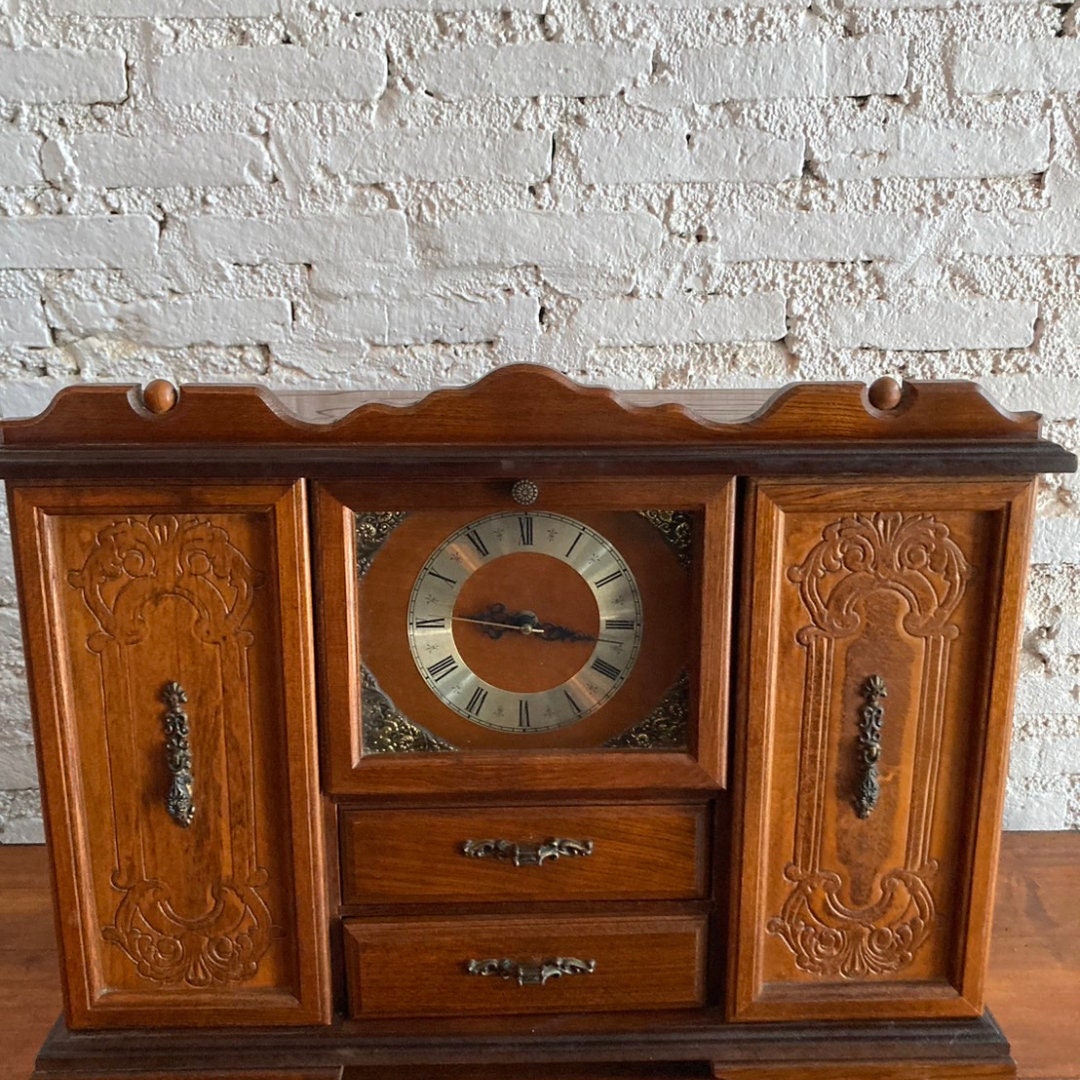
10,484,329,1027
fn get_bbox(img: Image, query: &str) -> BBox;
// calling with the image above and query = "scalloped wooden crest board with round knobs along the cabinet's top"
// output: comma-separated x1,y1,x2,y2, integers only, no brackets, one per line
0,364,1039,448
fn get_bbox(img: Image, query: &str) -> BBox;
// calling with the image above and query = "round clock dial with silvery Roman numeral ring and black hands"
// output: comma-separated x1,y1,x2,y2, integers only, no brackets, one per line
406,511,645,735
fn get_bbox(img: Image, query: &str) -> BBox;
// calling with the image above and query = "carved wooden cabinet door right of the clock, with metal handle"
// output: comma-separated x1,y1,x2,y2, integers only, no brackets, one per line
729,481,1032,1020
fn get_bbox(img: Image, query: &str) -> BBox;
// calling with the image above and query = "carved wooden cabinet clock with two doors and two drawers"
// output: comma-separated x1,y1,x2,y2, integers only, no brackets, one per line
0,366,1076,1080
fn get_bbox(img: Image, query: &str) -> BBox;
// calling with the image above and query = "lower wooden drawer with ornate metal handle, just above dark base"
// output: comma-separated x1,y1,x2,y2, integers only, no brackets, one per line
345,915,705,1017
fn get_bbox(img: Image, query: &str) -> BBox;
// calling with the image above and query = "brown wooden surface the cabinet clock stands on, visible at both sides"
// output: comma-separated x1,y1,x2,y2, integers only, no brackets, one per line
0,833,1080,1080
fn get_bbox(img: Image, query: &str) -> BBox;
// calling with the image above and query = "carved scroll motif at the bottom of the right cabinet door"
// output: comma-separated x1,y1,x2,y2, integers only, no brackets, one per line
767,863,937,981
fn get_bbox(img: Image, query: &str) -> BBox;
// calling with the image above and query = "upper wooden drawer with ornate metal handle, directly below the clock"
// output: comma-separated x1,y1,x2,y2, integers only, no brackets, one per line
341,804,710,904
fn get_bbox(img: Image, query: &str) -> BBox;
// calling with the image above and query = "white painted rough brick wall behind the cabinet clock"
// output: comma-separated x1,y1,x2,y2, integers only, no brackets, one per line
0,0,1080,840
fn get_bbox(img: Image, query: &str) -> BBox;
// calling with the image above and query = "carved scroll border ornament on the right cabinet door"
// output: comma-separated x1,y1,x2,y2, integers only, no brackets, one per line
768,513,971,980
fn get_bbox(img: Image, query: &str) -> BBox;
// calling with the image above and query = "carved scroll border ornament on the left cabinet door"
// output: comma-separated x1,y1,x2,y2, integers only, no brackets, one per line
68,514,274,987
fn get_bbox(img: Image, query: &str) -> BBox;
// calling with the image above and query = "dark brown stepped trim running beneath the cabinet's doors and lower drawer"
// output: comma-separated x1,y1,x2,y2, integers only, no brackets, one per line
36,1010,1011,1080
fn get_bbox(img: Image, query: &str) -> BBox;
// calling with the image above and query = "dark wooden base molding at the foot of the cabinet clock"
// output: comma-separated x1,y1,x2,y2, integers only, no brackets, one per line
32,1013,1016,1080
